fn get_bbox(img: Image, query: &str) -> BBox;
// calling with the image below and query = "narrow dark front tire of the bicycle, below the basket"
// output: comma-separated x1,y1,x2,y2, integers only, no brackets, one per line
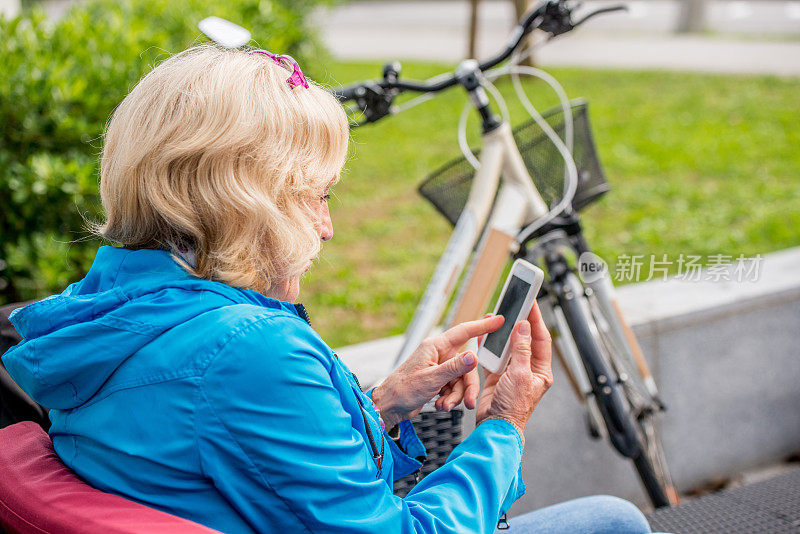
554,272,671,508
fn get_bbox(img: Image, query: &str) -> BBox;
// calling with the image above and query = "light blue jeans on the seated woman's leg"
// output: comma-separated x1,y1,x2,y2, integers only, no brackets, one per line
495,495,664,534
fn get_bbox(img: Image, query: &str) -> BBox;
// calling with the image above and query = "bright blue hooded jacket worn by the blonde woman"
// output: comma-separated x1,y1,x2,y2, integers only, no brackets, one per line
3,247,524,534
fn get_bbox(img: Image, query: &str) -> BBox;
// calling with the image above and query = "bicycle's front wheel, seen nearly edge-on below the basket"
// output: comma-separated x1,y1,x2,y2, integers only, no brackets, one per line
551,270,674,508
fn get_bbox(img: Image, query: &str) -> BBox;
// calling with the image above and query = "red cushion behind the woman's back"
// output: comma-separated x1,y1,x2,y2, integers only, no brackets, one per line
0,421,216,534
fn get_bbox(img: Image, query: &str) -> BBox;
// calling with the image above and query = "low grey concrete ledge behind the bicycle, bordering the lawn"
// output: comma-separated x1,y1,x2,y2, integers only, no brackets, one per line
337,248,800,513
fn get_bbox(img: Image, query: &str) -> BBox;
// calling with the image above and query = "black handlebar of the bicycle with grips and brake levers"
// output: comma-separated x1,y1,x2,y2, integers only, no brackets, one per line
331,0,627,126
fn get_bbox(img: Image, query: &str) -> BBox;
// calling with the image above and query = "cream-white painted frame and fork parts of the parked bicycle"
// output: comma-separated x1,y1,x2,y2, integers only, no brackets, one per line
394,100,658,408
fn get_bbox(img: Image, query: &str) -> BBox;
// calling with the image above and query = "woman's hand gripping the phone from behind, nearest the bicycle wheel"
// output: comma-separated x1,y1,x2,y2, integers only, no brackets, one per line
475,304,553,442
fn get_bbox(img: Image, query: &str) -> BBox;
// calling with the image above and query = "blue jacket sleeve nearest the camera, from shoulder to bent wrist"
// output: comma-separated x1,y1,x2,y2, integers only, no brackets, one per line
195,315,522,534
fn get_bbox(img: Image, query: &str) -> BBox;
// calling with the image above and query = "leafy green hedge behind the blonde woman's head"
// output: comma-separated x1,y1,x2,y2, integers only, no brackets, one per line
0,0,327,304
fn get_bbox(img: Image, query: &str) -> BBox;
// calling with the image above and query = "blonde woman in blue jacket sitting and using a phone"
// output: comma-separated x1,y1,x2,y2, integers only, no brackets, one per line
3,46,648,534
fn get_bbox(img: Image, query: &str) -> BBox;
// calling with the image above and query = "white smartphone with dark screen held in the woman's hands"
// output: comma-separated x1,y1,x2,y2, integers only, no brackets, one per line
478,260,544,373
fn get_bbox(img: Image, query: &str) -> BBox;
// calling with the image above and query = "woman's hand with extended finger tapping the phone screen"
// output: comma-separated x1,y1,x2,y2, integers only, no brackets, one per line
372,315,503,429
